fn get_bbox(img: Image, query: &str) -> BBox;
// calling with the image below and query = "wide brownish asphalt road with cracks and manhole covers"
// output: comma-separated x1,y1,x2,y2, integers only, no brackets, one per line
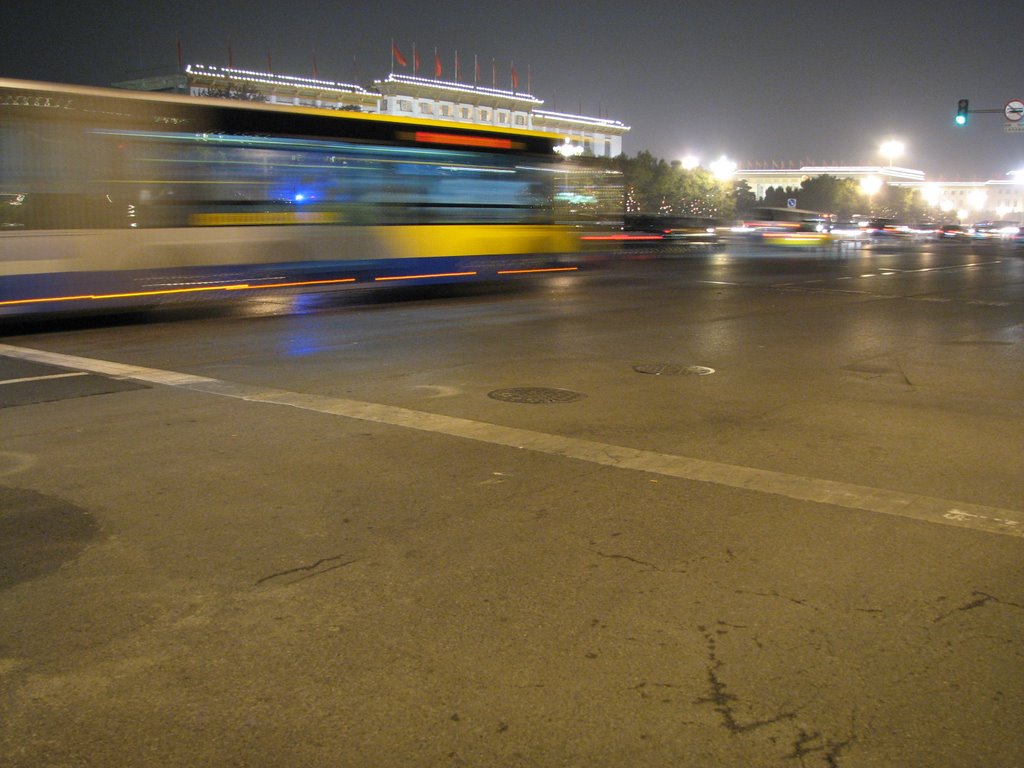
0,241,1024,768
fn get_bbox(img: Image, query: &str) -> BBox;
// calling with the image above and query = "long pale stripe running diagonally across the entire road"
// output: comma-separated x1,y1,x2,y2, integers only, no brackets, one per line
0,344,1024,538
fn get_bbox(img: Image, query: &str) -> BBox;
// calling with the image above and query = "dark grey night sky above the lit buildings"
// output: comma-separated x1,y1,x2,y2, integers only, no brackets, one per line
0,0,1024,179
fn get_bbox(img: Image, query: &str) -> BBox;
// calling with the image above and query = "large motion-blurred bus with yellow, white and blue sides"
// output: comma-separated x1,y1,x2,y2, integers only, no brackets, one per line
0,80,622,315
